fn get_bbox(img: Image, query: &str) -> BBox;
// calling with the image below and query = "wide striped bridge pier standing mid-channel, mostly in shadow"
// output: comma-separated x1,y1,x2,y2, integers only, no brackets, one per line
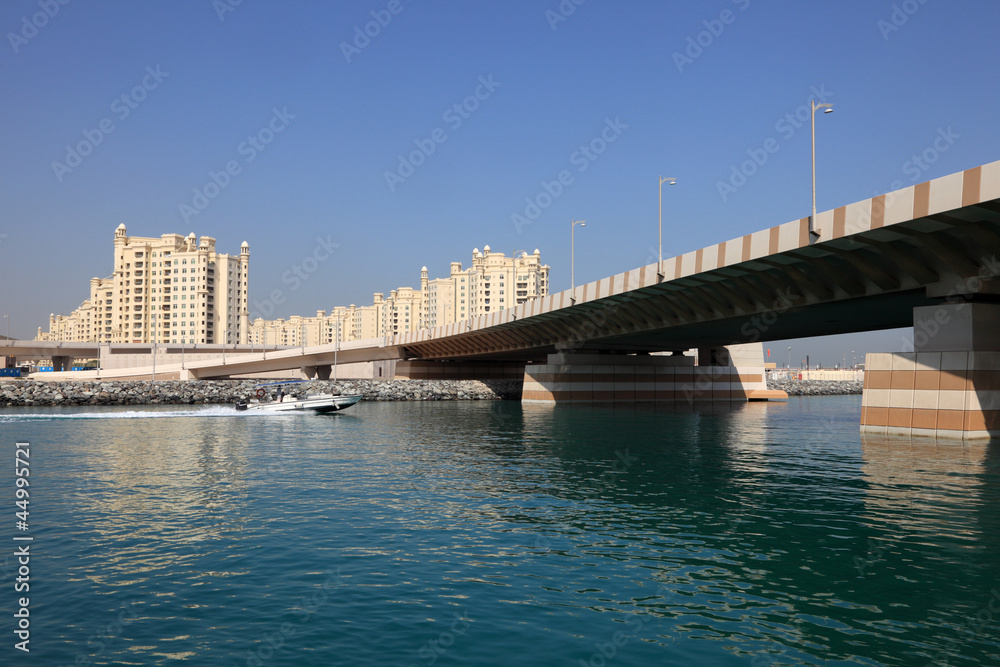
521,343,787,404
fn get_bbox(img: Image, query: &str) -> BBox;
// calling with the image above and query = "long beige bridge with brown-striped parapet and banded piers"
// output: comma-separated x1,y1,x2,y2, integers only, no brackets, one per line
0,161,1000,438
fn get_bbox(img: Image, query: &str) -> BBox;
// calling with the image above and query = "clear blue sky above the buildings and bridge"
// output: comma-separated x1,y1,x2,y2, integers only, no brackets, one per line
0,0,1000,363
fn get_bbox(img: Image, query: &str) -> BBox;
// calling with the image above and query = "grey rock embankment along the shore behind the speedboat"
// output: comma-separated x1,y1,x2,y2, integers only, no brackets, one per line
0,380,521,406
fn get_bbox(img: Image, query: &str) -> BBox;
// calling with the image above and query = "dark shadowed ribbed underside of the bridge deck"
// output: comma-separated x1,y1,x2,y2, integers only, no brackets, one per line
404,210,1000,361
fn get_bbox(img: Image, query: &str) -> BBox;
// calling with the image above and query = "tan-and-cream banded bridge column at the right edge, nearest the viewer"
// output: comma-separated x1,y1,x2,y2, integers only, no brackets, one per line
861,302,1000,440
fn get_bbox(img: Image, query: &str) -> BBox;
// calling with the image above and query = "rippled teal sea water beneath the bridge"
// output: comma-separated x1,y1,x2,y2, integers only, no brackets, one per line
0,397,1000,667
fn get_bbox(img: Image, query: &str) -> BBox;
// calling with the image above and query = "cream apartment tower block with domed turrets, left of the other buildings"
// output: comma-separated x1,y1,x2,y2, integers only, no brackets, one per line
36,223,250,344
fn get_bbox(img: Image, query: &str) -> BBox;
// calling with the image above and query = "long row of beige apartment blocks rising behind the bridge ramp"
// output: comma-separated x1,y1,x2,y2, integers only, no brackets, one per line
249,246,549,345
